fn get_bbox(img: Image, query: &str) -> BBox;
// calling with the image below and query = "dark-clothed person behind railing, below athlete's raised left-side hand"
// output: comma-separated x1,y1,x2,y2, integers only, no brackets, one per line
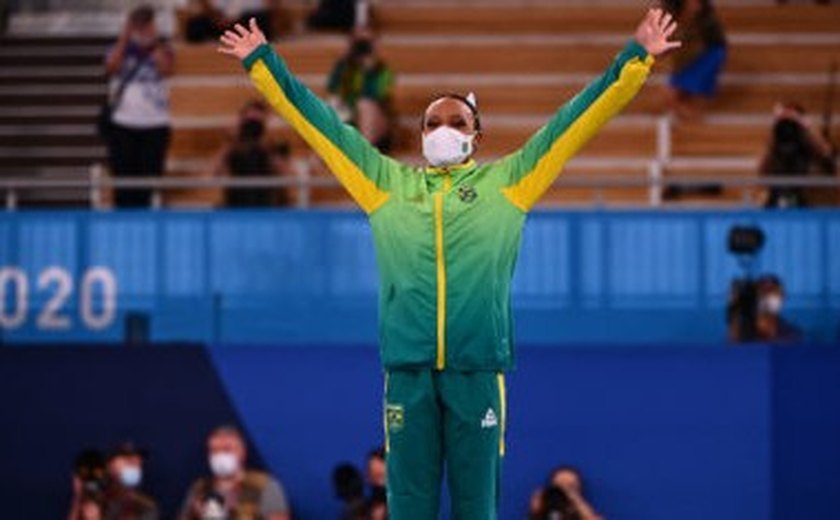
213,99,292,208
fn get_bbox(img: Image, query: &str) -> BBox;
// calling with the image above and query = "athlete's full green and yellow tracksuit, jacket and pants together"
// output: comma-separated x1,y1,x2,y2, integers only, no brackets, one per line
243,41,653,520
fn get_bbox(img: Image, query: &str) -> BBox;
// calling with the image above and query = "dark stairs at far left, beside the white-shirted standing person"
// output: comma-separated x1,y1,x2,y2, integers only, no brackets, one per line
0,36,109,207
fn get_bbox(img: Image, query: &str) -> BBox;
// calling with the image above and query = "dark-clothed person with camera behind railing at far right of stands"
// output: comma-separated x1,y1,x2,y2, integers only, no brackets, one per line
759,103,834,208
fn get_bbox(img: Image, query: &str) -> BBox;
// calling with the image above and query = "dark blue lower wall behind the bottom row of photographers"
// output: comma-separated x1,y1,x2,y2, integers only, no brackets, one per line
0,346,840,520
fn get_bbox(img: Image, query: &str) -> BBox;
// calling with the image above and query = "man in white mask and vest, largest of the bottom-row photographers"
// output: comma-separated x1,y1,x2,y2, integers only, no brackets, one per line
179,426,290,520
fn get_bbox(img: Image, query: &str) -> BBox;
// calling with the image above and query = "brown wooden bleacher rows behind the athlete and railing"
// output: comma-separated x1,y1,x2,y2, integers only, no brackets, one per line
170,2,840,206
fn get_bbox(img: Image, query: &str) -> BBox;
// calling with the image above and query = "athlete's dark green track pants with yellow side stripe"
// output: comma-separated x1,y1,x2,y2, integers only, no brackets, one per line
385,370,506,520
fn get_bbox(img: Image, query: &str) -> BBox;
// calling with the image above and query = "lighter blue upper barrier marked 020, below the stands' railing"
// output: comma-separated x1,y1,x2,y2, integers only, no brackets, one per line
0,207,840,344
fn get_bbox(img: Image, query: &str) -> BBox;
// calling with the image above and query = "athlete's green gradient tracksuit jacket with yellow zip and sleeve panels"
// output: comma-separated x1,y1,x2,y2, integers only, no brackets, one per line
243,41,653,371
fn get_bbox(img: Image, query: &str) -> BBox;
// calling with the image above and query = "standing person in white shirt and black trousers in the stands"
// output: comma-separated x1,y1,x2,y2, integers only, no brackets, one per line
105,6,174,207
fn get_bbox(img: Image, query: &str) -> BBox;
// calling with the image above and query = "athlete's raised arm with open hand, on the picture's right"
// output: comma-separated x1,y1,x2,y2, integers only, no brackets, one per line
501,9,680,211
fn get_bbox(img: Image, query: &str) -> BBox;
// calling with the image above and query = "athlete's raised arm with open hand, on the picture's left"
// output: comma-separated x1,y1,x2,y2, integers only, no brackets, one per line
219,18,390,214
